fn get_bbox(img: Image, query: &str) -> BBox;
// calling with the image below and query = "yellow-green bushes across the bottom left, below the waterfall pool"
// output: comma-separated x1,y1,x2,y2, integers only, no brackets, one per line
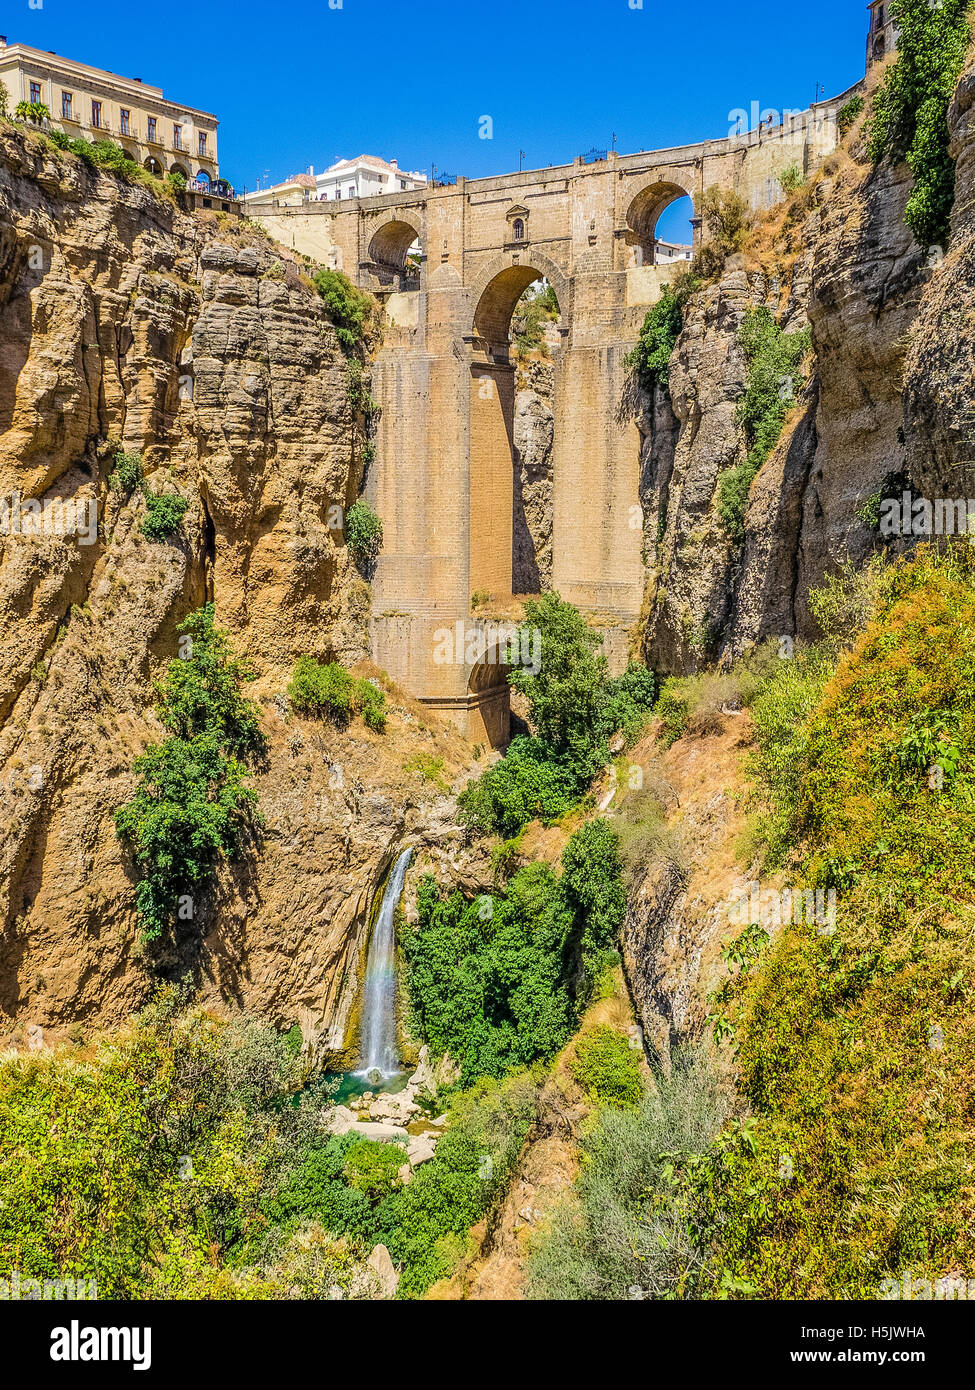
0,991,537,1300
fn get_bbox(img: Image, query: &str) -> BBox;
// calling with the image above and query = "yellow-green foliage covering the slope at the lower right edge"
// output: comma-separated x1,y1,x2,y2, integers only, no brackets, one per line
691,548,975,1298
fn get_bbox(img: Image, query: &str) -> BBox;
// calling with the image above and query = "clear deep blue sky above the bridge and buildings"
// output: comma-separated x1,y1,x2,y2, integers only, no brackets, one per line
13,0,867,236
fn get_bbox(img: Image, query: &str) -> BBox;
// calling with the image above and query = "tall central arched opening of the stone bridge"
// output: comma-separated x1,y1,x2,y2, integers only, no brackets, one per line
470,265,563,602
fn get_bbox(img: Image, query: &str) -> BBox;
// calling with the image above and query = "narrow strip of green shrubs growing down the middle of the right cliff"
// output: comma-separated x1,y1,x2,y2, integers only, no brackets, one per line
718,304,809,541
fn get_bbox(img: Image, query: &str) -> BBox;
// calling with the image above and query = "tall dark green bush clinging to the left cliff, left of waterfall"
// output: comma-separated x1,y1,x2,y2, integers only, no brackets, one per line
115,605,264,941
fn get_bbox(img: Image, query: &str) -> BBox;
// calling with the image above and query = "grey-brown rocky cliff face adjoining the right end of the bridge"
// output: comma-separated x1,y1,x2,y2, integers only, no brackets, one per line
643,112,929,671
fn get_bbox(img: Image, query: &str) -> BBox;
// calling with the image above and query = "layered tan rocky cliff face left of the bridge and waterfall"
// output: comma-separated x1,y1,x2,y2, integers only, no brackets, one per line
0,125,478,1045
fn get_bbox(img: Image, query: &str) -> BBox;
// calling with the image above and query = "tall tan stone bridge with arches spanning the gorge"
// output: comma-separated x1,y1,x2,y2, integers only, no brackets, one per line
253,89,855,746
